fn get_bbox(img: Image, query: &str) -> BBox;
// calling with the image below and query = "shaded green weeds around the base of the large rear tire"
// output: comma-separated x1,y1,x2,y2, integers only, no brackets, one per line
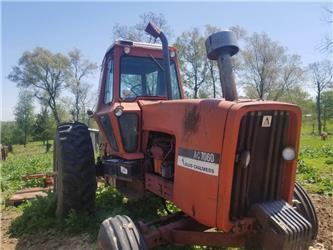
10,186,164,240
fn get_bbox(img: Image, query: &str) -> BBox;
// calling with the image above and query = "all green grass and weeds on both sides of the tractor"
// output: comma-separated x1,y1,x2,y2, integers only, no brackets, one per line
1,120,333,246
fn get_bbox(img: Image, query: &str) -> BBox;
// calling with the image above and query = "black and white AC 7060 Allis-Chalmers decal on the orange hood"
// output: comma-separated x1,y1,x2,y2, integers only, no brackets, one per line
177,148,220,176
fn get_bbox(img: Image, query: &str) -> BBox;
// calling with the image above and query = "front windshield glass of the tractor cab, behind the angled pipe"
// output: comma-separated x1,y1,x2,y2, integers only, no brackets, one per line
120,56,180,100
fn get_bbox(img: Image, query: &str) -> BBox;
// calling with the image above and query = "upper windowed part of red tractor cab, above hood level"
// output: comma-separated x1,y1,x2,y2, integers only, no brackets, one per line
99,40,182,105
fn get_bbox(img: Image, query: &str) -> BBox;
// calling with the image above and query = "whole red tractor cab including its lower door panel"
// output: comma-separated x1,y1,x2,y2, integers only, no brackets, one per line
94,37,184,159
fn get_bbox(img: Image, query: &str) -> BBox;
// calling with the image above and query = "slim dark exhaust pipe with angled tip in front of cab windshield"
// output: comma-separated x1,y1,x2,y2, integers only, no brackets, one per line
145,22,172,100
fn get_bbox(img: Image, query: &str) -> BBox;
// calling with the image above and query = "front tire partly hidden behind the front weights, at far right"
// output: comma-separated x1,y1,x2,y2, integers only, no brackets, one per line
293,183,318,240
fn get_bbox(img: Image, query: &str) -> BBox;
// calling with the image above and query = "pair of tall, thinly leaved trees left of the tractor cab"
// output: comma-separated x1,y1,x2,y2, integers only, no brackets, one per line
8,47,97,125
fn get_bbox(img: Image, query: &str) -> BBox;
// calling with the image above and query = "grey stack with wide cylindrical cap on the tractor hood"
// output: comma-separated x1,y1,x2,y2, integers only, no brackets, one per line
206,31,239,101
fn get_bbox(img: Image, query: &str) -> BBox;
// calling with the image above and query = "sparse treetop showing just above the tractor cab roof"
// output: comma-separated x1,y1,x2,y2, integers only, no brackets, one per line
112,11,172,43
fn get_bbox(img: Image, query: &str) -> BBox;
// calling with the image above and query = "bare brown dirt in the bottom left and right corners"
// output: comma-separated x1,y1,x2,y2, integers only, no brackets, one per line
0,194,333,250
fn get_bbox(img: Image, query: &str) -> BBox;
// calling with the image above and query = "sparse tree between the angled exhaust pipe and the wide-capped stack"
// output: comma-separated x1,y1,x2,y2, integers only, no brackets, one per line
175,28,208,98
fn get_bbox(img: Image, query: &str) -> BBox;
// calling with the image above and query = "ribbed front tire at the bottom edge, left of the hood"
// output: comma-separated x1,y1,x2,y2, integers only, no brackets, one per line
97,215,147,250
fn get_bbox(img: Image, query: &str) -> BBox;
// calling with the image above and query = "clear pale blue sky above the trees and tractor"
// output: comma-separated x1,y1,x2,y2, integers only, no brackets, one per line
0,1,332,121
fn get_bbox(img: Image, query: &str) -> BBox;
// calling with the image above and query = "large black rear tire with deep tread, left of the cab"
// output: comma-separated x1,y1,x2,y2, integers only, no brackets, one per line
54,122,97,217
